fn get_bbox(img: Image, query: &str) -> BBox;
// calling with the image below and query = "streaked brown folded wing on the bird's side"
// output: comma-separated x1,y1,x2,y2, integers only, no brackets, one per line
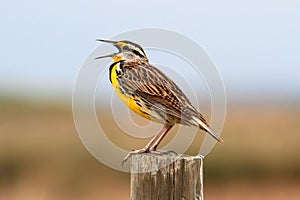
119,63,195,120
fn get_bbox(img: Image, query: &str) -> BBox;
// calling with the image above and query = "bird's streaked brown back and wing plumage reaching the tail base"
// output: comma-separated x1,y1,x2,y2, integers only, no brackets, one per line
118,61,207,126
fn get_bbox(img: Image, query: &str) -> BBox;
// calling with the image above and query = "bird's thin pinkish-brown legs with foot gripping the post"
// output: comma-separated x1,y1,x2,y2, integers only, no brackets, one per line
122,124,173,165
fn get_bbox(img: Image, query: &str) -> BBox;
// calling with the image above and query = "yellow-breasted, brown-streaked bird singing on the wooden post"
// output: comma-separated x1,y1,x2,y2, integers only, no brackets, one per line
95,39,223,164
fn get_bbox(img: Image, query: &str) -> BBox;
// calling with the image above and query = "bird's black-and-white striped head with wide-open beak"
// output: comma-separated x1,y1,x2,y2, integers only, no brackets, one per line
95,39,148,62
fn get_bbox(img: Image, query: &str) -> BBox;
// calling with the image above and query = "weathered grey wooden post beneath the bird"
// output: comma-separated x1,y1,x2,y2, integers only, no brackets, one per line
130,154,203,200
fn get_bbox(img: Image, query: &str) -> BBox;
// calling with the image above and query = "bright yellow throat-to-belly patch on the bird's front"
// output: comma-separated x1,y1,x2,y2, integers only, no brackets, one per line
110,63,150,119
